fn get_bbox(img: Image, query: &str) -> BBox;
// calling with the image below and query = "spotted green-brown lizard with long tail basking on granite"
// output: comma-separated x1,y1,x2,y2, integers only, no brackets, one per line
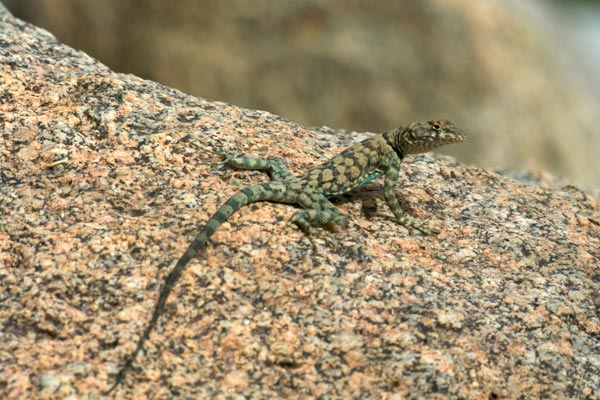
107,120,466,393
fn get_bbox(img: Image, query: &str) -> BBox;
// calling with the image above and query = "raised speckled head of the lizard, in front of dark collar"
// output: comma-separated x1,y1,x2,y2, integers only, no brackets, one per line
398,119,467,154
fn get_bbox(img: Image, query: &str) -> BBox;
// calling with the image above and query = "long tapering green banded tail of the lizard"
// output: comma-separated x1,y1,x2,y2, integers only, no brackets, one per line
106,182,285,394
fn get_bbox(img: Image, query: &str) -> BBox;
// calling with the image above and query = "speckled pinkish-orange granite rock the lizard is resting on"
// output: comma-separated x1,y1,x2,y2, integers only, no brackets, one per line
0,8,600,399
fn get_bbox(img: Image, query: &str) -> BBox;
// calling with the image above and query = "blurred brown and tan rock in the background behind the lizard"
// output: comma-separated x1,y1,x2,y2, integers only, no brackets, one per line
3,0,600,187
